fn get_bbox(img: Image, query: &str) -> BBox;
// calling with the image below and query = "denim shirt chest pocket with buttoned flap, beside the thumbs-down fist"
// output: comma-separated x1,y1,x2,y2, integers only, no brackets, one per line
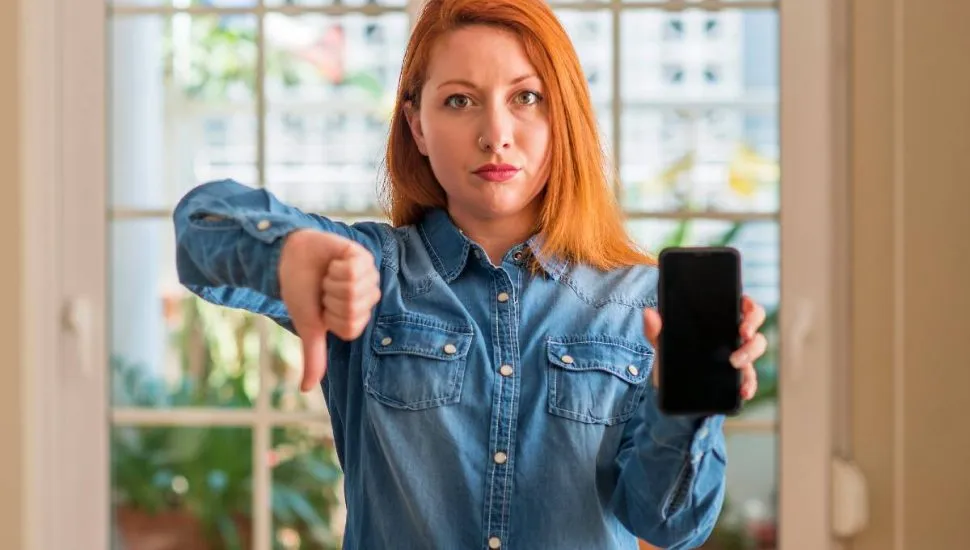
364,313,473,410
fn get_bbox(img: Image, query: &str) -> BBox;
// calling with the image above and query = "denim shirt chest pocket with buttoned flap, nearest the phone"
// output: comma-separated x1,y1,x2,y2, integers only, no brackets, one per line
547,335,653,425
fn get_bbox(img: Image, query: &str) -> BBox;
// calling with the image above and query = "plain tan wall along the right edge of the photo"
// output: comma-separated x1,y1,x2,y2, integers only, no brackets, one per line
851,0,970,550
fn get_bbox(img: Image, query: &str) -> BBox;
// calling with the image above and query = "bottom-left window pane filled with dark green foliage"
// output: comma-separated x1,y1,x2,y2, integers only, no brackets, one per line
111,426,253,550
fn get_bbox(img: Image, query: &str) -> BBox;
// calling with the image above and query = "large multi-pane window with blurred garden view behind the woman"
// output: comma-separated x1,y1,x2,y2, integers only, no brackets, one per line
24,0,840,550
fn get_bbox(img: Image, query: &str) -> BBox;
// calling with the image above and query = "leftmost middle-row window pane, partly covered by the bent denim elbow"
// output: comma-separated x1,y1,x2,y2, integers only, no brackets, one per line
109,219,260,408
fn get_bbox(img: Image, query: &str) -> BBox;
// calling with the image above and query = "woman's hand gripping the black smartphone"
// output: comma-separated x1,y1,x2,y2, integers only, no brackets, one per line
643,296,768,401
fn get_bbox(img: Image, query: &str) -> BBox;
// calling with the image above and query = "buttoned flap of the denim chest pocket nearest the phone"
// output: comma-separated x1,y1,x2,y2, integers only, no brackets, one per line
547,335,653,384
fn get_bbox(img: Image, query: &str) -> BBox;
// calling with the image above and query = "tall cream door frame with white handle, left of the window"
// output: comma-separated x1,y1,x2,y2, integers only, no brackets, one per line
19,0,110,550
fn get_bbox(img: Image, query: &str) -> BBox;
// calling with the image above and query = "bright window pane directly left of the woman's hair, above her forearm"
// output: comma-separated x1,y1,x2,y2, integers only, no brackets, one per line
266,12,408,211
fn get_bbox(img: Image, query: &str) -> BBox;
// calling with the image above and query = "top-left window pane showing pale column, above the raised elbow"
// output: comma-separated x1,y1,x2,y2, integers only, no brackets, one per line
109,13,256,209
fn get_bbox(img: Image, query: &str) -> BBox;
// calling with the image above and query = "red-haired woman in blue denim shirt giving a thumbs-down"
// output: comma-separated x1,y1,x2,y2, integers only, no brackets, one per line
175,0,764,550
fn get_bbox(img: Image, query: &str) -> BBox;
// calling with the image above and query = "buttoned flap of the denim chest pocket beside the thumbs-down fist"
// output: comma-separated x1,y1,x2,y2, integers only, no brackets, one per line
371,313,474,361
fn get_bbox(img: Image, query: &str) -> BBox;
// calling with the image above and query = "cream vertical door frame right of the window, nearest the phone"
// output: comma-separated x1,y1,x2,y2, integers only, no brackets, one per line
779,0,851,550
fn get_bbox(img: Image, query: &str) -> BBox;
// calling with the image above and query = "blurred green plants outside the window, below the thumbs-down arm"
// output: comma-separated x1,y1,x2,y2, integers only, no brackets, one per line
111,296,340,550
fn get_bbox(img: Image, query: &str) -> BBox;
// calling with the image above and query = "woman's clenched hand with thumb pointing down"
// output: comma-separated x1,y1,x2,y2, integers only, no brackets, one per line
279,229,381,391
